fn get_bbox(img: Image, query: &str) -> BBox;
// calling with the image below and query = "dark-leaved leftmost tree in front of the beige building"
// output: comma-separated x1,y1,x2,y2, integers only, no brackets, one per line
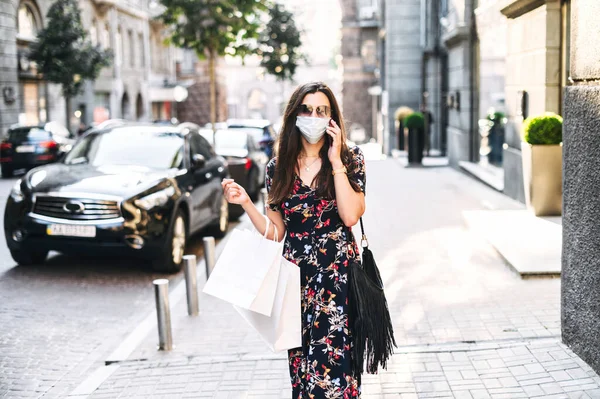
29,0,112,133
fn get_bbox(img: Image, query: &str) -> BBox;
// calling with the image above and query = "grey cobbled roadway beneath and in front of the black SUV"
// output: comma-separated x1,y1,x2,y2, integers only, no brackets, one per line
0,176,231,398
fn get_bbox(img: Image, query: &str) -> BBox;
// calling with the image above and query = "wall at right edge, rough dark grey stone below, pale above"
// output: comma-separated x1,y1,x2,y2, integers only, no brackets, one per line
561,0,600,373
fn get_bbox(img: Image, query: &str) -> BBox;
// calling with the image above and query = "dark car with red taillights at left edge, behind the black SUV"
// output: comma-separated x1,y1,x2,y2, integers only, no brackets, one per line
0,122,75,177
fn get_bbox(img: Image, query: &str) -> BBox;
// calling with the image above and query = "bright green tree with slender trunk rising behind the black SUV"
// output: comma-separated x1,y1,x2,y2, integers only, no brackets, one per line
157,0,267,129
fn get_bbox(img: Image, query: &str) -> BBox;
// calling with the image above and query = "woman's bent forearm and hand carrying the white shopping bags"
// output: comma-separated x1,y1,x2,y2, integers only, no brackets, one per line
221,179,285,241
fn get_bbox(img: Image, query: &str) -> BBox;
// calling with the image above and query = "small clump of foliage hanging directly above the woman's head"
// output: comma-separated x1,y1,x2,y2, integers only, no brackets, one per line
257,4,306,80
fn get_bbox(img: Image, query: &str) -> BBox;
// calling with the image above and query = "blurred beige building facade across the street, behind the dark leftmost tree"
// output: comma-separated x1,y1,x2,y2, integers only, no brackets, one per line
0,0,197,134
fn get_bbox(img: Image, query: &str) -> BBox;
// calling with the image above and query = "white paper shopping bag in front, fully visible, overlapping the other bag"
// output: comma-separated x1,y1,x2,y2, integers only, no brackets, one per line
203,229,283,316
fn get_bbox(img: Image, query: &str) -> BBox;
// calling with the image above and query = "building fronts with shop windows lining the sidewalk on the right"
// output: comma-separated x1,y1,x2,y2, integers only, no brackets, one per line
384,0,571,202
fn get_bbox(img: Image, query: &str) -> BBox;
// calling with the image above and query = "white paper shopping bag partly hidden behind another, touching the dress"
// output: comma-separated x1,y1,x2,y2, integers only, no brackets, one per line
235,257,302,352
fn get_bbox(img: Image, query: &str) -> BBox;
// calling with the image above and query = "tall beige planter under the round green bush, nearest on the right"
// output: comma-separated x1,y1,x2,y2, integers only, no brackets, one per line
521,142,562,216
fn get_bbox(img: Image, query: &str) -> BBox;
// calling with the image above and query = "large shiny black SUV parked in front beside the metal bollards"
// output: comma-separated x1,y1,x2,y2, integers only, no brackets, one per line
4,123,229,272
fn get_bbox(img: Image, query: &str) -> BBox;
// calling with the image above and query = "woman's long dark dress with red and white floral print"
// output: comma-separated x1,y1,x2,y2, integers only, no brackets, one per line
266,147,365,399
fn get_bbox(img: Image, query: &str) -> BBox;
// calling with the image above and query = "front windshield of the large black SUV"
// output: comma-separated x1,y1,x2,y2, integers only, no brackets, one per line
65,130,184,169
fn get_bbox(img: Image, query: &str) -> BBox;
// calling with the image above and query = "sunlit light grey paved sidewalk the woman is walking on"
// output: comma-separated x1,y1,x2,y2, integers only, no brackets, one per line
84,159,600,399
